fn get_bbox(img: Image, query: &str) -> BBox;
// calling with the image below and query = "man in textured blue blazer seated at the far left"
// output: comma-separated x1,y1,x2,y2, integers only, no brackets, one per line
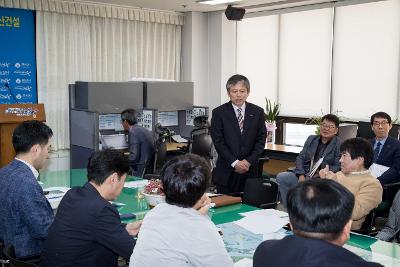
0,121,53,258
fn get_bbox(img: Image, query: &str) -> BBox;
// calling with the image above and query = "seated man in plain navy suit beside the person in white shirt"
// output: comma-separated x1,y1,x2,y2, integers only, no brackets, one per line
42,150,140,267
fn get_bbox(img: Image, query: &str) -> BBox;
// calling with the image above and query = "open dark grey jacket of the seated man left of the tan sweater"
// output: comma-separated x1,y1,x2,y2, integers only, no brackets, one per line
294,135,340,175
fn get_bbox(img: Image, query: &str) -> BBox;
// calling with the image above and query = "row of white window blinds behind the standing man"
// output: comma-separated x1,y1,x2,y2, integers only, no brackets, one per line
237,0,400,120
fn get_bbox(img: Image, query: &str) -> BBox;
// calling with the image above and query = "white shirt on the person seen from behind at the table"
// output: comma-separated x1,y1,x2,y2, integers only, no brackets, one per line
129,203,234,267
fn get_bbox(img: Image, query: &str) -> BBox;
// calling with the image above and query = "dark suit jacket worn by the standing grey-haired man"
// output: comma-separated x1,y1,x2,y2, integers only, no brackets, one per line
211,102,266,185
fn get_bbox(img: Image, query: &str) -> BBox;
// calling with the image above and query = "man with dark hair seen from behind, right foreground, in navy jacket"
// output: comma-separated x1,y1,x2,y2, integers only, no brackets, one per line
253,179,381,267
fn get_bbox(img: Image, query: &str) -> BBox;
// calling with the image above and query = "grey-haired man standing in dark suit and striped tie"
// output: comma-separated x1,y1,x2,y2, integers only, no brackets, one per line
211,74,266,193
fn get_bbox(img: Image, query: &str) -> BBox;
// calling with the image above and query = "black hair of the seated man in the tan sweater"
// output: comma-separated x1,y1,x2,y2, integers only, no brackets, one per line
340,137,374,169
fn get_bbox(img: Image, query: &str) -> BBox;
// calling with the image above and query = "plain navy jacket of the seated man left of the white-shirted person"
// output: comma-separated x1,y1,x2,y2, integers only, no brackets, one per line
41,183,135,267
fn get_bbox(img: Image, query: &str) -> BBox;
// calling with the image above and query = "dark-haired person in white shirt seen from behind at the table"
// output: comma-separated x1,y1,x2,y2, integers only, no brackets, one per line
129,154,233,267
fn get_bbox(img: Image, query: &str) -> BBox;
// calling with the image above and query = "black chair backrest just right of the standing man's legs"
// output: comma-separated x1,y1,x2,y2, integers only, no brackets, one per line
243,178,278,208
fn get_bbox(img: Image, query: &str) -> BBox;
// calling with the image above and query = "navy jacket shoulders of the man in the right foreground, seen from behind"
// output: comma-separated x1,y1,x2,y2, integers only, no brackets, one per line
253,235,382,267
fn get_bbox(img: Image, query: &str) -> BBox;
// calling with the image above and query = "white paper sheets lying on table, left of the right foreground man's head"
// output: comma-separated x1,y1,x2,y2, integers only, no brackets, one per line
233,215,288,234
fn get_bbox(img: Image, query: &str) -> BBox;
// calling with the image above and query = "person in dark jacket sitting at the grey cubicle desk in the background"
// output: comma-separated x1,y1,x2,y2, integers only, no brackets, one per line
121,109,154,177
